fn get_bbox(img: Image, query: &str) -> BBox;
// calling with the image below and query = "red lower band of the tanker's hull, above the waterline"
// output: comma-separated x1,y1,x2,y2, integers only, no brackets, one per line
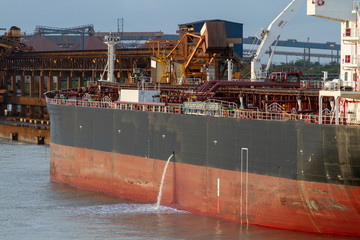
50,143,360,236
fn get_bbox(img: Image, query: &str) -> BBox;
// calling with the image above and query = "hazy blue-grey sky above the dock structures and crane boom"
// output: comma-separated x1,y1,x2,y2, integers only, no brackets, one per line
0,0,340,43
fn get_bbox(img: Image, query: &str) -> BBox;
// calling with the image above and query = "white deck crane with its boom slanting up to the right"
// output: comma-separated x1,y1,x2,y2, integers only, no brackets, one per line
251,0,306,81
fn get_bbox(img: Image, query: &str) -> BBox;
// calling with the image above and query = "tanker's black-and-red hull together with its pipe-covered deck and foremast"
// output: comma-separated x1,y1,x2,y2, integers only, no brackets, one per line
45,0,360,237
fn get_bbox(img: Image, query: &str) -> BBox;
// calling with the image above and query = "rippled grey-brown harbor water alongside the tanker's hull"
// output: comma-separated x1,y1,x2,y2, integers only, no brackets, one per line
0,139,353,240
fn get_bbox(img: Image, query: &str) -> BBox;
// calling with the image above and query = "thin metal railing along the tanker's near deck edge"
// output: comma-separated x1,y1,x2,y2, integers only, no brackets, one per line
46,98,360,125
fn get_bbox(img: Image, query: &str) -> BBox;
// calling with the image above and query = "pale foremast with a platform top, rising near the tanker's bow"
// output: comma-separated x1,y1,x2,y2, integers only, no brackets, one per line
101,33,120,82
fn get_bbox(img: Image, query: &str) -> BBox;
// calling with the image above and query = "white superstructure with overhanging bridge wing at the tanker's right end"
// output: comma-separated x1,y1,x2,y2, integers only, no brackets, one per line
307,0,360,125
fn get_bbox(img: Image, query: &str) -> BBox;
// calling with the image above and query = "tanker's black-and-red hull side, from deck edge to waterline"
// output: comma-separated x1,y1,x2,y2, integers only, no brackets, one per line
47,86,360,236
